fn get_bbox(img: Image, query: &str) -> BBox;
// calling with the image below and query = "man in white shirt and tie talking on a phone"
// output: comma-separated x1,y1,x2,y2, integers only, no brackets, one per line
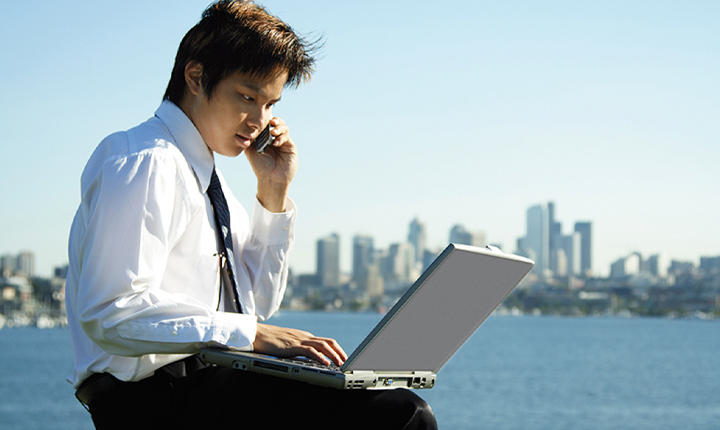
66,1,436,428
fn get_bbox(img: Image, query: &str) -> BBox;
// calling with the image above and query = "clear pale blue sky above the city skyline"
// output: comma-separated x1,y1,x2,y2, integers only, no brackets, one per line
0,0,720,275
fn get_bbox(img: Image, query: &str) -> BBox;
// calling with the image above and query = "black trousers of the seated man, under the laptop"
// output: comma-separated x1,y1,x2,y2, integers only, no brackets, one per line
84,356,437,430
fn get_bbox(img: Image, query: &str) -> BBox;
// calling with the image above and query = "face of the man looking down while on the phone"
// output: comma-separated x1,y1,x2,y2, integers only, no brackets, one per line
181,72,287,157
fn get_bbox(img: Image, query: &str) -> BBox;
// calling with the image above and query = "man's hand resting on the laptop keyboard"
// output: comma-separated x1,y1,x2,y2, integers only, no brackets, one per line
253,323,347,366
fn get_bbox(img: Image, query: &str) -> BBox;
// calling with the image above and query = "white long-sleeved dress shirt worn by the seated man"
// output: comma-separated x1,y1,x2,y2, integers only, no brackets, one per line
65,101,296,388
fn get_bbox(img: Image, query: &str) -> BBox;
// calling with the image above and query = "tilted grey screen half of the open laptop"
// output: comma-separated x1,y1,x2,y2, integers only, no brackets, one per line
343,244,534,372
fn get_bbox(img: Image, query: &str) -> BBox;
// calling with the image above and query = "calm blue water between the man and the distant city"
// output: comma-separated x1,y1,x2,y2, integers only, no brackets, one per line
0,312,720,430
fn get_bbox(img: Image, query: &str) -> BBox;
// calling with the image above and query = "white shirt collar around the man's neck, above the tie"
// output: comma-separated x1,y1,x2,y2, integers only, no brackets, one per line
155,100,215,192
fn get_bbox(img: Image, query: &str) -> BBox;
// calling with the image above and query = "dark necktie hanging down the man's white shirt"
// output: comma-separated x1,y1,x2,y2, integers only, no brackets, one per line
207,167,242,313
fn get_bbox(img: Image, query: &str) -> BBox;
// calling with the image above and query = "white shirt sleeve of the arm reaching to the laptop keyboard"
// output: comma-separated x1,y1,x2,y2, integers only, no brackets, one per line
76,152,256,356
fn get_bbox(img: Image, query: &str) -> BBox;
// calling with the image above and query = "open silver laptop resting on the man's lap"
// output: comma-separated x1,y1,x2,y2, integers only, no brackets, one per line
200,244,535,389
